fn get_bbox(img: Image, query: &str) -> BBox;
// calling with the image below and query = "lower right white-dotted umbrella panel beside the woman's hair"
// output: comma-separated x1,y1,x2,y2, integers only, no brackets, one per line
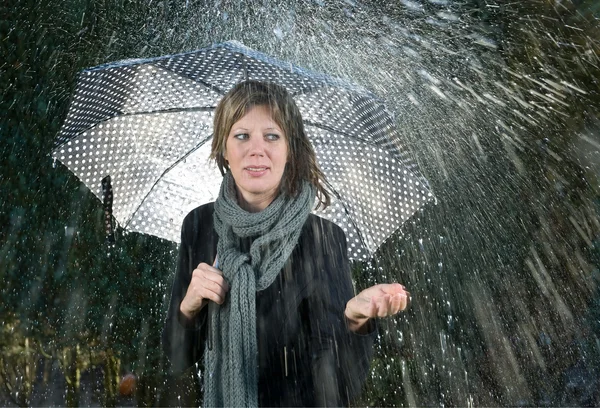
310,129,431,259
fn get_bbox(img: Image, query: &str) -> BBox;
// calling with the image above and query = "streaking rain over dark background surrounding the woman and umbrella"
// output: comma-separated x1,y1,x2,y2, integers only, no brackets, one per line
0,0,600,406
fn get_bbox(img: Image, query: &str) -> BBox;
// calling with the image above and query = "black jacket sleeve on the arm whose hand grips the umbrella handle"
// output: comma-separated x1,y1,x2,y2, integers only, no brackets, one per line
162,217,208,374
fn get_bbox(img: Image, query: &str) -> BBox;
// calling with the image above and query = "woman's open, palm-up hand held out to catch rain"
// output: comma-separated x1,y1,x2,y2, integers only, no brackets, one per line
344,283,410,333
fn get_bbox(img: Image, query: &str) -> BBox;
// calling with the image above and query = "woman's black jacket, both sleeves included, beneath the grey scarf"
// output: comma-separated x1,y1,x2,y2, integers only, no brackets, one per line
163,203,373,406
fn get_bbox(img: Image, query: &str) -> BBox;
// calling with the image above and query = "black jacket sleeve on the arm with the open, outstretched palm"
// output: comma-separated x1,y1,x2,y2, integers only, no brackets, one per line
309,224,376,406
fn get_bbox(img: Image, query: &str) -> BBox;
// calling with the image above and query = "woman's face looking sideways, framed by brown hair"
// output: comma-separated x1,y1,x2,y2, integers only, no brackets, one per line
224,106,288,211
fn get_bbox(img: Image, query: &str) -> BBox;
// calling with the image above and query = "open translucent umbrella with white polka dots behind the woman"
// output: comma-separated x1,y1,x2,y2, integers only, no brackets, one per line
52,42,433,260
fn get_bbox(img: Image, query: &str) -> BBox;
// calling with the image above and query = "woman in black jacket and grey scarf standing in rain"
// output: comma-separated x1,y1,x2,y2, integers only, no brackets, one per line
163,81,408,406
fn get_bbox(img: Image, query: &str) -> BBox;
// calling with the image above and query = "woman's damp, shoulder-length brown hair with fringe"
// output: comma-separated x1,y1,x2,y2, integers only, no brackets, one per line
210,81,331,209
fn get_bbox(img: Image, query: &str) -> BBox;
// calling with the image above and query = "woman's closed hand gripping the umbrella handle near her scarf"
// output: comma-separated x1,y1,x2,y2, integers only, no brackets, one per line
179,262,229,319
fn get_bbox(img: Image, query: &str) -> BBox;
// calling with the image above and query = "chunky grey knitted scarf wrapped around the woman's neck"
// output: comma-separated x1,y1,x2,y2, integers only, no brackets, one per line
204,172,315,407
